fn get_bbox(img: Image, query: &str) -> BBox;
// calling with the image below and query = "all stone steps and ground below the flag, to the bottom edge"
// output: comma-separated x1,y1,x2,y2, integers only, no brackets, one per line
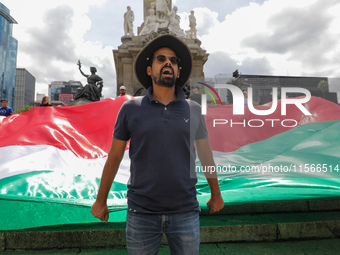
0,200,340,255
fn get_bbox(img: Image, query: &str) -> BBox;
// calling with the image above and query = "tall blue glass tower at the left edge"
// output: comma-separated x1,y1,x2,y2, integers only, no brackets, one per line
0,3,18,107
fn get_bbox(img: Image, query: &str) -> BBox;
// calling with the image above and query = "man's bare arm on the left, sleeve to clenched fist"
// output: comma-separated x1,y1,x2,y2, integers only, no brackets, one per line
91,138,127,223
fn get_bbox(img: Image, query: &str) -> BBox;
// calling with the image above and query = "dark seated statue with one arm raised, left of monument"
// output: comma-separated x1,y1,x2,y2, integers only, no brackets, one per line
74,60,103,101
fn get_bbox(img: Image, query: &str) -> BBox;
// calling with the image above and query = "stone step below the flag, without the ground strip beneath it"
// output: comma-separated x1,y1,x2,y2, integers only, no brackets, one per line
0,199,340,251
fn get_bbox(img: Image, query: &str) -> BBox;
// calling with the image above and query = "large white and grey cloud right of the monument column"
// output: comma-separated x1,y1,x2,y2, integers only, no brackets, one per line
198,0,340,77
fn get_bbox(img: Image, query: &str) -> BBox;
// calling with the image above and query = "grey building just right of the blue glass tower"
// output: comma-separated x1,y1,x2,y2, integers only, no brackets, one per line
14,68,35,111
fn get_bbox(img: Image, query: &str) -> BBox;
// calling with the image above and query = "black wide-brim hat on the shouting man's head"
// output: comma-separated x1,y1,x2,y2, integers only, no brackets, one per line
134,34,192,89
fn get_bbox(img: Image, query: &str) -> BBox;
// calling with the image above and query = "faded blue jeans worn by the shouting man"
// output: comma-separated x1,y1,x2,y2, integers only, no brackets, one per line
126,210,200,255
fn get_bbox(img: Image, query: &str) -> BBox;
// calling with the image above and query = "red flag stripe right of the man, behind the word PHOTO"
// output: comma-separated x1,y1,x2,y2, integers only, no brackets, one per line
205,97,340,152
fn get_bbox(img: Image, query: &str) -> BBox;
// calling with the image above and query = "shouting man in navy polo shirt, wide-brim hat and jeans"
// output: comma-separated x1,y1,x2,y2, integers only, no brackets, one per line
92,35,224,254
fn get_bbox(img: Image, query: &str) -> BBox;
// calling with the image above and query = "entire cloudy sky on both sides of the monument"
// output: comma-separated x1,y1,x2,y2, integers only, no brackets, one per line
0,0,340,97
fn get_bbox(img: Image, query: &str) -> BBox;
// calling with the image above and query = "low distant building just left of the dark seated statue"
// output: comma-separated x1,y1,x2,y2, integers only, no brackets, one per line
48,81,83,105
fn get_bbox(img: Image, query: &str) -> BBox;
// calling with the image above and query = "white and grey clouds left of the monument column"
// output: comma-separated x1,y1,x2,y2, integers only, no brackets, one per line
2,0,115,97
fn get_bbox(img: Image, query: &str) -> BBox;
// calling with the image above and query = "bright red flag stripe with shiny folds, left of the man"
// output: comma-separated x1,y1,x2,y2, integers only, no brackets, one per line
0,97,129,158
